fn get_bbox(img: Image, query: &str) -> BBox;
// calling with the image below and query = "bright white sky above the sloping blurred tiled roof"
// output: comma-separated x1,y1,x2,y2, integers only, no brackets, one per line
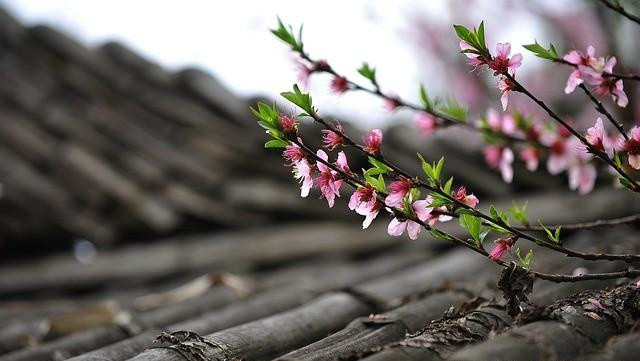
0,0,568,126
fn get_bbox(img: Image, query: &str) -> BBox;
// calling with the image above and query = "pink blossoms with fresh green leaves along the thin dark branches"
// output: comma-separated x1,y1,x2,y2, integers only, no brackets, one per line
264,16,640,270
